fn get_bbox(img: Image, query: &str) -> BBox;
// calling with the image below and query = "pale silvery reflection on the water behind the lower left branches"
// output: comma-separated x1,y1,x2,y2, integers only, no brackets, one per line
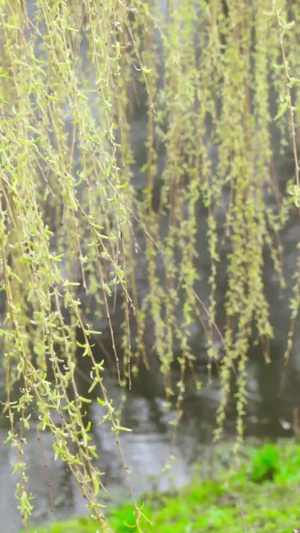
0,374,192,533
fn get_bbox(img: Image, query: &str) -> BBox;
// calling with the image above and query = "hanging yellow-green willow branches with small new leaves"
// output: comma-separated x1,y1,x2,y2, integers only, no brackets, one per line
0,0,300,530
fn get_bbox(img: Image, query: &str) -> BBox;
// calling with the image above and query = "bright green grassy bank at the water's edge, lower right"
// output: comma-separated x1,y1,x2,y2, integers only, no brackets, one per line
24,443,300,533
